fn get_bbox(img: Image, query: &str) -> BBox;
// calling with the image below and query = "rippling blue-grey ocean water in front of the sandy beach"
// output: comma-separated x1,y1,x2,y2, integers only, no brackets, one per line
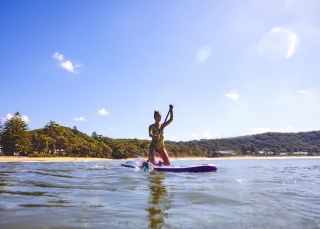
0,158,320,229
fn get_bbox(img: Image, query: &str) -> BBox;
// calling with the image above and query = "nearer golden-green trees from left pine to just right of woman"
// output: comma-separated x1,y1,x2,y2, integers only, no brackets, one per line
0,112,208,159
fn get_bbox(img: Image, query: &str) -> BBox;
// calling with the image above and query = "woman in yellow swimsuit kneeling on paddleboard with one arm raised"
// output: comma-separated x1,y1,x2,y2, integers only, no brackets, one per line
149,105,173,165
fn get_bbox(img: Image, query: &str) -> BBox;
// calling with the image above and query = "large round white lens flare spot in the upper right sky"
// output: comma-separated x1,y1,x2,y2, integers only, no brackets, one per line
257,27,299,62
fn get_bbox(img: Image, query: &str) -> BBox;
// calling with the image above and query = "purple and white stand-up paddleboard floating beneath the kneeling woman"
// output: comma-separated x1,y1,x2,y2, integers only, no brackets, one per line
121,162,217,173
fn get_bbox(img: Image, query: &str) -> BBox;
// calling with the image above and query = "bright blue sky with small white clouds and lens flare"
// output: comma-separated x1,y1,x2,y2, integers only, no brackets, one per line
0,0,320,141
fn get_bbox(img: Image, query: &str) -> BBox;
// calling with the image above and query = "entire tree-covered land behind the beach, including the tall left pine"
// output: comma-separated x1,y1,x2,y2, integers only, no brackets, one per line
0,112,320,159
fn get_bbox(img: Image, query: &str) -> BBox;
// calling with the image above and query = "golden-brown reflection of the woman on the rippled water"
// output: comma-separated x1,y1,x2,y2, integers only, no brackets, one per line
147,172,170,228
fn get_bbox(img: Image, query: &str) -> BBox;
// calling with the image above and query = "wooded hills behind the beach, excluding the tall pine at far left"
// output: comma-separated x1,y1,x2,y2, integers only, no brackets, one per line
31,123,320,158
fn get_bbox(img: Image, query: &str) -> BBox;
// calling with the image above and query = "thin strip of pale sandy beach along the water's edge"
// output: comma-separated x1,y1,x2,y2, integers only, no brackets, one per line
0,156,320,163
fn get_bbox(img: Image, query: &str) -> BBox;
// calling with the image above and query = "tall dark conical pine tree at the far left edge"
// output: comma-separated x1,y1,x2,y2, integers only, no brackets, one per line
1,112,31,155
